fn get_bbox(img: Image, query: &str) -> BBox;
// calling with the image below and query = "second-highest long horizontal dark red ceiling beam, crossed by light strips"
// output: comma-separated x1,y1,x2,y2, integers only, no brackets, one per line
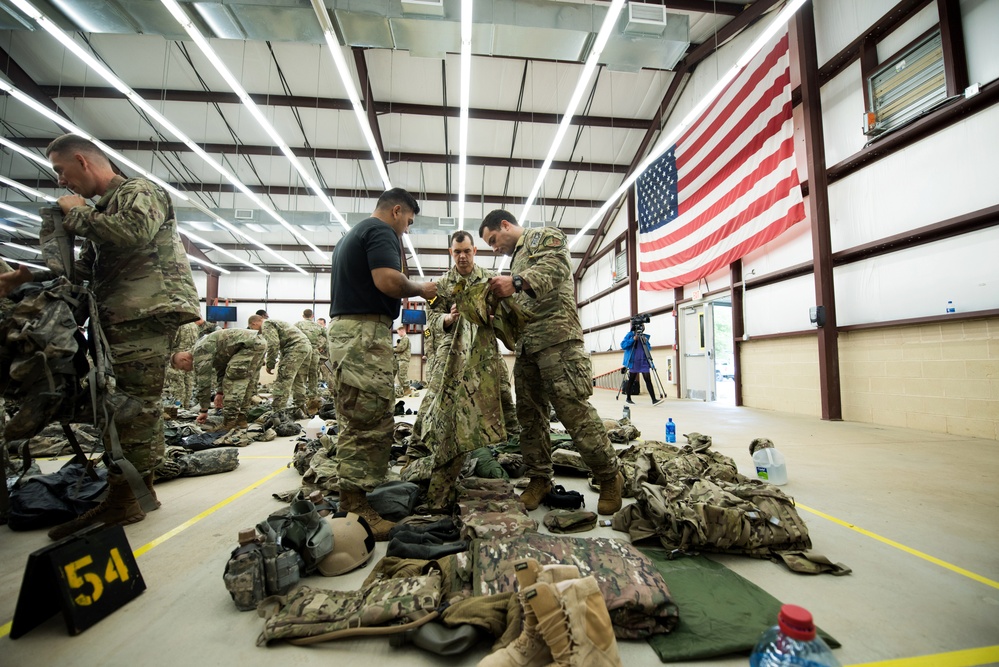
11,137,628,174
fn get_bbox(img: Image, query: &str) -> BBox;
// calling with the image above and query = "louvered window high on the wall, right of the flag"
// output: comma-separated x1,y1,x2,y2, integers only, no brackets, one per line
864,31,947,137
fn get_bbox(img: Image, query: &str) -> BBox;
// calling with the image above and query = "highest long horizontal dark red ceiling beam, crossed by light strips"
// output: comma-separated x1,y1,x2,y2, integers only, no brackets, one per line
39,85,649,130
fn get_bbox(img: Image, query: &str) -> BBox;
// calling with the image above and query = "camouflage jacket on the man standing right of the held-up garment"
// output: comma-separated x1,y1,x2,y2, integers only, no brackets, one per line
510,227,583,356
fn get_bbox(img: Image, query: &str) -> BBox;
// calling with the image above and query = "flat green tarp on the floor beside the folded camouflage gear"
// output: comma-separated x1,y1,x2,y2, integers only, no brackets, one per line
640,548,840,662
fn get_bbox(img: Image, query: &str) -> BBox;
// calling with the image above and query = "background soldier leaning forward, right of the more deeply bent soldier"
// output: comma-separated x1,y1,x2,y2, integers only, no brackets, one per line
247,315,312,419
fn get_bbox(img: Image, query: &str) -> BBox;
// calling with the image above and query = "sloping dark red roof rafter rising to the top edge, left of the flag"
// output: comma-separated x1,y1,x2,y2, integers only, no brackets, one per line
575,0,783,280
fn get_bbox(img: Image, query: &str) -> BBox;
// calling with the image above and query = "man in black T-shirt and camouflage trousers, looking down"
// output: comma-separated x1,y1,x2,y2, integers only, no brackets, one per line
329,188,437,541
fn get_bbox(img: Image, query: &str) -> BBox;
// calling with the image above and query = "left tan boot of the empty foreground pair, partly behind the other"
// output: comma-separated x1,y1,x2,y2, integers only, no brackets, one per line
479,558,579,667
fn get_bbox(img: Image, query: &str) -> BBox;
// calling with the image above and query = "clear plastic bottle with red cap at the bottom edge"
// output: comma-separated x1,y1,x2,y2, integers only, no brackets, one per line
749,604,842,667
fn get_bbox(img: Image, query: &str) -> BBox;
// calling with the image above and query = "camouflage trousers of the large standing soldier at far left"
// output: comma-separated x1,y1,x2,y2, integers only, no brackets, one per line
104,315,177,475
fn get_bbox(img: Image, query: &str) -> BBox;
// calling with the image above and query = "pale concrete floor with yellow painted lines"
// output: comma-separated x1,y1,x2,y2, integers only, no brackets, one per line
0,390,999,667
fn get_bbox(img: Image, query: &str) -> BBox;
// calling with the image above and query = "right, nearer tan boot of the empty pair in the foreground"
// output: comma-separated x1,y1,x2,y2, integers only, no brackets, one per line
525,577,623,667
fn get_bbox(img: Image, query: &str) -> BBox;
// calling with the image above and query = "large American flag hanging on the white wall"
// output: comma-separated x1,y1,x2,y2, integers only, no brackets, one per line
635,31,805,290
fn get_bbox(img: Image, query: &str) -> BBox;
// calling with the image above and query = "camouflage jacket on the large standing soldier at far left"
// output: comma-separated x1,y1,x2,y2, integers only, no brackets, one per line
36,176,201,325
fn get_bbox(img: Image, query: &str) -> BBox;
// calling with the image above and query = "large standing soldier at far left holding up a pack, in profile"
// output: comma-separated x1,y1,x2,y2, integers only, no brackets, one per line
0,134,201,539
